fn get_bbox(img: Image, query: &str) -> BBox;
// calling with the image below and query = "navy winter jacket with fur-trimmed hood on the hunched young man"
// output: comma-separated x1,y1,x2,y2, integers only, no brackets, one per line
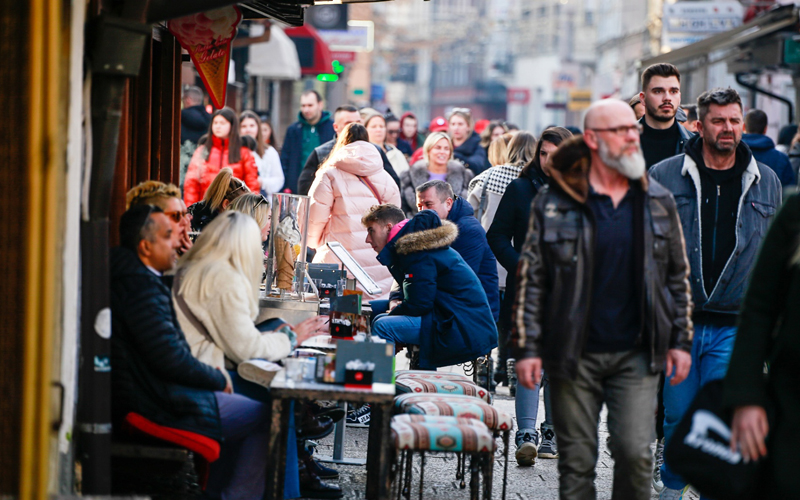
378,210,497,369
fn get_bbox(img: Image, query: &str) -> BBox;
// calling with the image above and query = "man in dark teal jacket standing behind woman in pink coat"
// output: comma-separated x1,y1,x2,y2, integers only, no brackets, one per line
281,90,335,193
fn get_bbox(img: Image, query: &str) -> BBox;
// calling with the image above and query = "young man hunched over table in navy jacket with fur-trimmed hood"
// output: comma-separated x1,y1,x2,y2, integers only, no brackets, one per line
362,204,497,369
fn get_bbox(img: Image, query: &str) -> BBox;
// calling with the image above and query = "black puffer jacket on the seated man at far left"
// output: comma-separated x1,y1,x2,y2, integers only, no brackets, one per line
111,247,226,440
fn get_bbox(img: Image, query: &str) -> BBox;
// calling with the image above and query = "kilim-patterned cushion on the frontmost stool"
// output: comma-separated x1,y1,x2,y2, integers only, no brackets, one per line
391,415,497,453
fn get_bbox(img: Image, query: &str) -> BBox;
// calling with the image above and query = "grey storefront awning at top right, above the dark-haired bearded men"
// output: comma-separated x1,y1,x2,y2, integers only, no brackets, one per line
641,5,798,70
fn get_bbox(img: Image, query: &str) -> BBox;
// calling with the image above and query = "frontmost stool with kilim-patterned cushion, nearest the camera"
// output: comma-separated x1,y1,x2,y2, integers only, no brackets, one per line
391,415,497,500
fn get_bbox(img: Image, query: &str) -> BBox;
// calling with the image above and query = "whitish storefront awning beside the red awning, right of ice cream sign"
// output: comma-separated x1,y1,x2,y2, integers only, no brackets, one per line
245,24,300,80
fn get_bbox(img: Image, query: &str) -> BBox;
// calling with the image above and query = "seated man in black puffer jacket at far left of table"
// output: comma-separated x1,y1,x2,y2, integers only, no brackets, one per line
111,205,269,498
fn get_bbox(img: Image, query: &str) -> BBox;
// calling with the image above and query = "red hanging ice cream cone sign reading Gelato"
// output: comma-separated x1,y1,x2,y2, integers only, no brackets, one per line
167,5,242,109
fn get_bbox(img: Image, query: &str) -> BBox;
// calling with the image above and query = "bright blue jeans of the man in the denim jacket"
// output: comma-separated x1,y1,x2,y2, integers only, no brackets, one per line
661,323,736,490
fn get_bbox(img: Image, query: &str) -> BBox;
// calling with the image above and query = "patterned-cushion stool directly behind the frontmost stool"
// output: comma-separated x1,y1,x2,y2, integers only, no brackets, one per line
394,393,514,499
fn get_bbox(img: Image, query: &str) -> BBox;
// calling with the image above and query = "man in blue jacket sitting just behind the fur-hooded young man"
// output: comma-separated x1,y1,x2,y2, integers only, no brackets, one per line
417,180,500,321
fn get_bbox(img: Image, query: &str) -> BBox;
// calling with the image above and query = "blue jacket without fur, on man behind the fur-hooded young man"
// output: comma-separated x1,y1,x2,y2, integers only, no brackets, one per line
447,196,500,321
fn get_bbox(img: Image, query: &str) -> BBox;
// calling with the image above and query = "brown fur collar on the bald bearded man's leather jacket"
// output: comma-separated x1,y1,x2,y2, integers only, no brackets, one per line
548,135,648,204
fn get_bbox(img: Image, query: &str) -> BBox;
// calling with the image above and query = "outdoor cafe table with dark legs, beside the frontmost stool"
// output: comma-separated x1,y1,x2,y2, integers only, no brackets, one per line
266,370,395,500
